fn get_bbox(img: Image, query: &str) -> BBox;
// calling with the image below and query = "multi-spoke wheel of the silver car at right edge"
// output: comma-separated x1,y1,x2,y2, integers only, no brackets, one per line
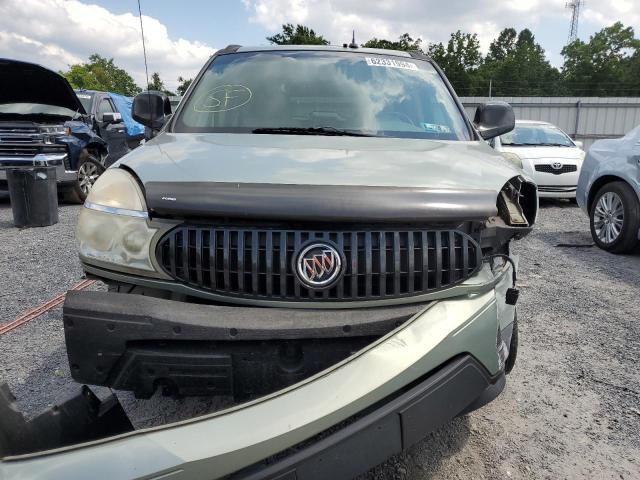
590,182,640,253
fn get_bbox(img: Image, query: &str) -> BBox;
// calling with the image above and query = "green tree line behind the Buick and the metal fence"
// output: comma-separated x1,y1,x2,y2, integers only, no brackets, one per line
61,22,640,97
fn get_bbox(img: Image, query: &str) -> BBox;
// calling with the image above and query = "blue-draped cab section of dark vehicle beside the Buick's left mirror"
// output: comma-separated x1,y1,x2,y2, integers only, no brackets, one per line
75,90,144,157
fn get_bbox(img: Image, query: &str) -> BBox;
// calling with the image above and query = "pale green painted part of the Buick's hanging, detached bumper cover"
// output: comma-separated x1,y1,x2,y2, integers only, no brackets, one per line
0,269,510,480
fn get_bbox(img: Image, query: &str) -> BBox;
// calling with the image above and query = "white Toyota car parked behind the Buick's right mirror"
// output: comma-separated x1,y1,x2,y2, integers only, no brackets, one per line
492,120,584,199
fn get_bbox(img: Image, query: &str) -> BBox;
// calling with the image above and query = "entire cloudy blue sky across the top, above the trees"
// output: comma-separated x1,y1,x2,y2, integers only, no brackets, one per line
0,0,640,89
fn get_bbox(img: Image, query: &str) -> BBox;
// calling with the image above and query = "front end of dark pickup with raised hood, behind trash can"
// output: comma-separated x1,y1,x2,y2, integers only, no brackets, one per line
0,59,110,202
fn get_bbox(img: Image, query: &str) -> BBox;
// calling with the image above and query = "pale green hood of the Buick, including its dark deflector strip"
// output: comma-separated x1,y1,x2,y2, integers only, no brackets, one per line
116,133,522,223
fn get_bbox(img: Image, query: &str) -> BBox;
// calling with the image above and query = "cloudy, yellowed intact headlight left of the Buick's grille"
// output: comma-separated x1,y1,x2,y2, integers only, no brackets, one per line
76,168,157,275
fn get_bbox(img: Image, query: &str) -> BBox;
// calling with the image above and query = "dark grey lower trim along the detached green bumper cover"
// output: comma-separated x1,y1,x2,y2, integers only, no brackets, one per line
229,355,504,480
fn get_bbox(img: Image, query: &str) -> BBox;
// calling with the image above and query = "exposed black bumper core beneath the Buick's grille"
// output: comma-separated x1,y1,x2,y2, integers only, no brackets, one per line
58,291,425,399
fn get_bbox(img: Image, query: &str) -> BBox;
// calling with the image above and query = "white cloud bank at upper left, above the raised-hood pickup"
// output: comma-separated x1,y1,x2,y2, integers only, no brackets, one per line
0,0,215,89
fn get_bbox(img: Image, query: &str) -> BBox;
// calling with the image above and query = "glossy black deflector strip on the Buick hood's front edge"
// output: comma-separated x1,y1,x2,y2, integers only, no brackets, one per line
145,182,498,223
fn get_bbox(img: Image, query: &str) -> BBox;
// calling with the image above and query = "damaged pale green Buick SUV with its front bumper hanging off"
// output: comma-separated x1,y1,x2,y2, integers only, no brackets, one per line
2,45,538,479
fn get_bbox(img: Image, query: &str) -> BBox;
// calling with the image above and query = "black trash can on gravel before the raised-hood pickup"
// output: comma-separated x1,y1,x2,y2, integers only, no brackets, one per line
7,167,58,228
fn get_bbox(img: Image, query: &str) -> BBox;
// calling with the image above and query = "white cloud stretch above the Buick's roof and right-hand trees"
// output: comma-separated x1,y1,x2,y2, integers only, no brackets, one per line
242,0,640,51
